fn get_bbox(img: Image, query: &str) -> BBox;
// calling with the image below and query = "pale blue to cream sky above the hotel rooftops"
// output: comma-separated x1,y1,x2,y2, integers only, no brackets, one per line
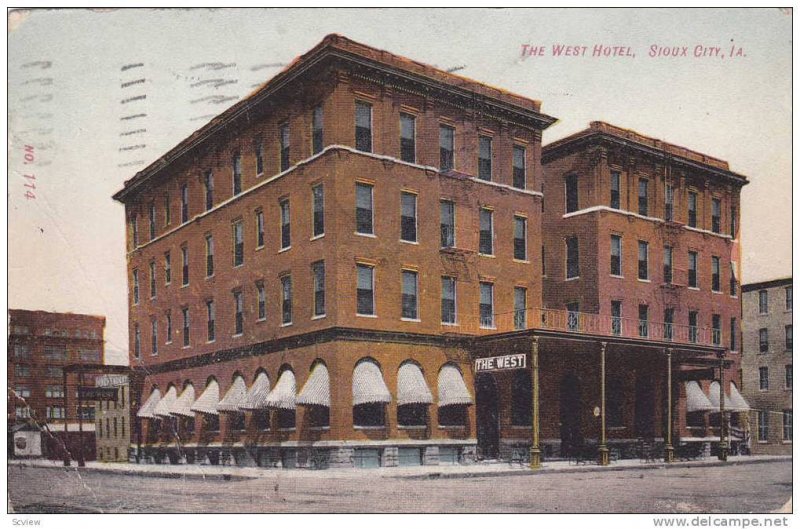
8,9,792,362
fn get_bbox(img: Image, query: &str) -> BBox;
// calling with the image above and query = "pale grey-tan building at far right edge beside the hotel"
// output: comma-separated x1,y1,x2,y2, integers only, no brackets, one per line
742,277,793,454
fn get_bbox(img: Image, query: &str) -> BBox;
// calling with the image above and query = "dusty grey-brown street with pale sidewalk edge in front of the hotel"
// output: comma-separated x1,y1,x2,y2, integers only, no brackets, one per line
8,458,792,513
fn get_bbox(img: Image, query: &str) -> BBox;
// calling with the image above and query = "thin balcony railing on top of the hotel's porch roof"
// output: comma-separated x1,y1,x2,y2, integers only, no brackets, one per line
442,308,721,346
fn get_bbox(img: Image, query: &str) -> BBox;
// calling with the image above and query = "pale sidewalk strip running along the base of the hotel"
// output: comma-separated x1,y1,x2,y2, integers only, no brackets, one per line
9,456,792,481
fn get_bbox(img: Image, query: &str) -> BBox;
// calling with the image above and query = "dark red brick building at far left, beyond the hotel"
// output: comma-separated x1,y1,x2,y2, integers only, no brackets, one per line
8,309,105,459
